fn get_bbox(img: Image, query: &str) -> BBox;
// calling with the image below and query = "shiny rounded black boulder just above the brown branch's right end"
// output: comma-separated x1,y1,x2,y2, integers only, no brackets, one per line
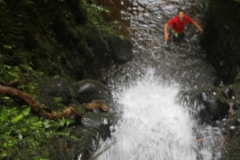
74,79,112,103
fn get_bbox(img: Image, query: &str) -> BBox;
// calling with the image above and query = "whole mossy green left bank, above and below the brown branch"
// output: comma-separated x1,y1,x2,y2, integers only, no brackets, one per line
0,0,120,160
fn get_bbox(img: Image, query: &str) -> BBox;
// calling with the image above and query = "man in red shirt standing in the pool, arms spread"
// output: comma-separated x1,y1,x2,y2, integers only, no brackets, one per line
164,10,203,41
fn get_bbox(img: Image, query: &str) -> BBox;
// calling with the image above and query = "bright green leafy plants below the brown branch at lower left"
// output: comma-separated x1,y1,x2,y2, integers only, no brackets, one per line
0,103,72,159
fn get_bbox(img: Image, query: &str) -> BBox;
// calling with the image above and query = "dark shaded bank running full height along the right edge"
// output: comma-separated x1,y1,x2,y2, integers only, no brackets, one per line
201,0,240,160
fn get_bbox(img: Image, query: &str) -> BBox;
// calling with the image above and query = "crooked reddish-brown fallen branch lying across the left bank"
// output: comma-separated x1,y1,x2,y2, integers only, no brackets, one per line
0,85,81,119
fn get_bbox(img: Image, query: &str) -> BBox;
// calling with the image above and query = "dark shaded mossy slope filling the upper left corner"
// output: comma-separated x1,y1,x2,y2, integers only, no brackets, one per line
0,0,111,80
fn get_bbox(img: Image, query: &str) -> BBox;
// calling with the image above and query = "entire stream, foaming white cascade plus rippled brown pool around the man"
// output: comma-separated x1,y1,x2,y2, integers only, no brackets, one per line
95,0,222,160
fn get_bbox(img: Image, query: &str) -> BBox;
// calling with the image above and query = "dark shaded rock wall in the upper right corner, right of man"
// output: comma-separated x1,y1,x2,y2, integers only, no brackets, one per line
201,0,240,84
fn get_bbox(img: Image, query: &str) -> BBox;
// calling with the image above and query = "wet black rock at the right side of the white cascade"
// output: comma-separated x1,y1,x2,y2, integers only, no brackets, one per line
199,93,230,123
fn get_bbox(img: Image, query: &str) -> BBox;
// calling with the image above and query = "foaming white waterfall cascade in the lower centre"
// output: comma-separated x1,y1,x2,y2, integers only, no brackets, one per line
96,72,221,160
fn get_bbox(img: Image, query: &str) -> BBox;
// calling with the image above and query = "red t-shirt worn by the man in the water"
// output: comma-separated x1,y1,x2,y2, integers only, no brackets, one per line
167,15,193,33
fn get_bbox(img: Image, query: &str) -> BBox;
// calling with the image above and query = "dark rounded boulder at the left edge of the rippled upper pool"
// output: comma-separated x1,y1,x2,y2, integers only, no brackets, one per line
107,36,133,63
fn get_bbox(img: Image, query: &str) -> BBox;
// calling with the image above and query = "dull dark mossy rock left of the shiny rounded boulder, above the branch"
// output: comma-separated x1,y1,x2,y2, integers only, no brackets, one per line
39,78,73,108
